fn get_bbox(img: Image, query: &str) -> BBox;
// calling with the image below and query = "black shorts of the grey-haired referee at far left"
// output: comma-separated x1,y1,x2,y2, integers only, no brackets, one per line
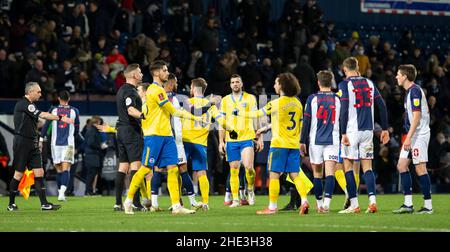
13,135,43,172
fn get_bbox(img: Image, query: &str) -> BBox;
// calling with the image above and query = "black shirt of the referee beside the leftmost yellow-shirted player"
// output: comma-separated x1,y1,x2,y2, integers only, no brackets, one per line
116,83,142,130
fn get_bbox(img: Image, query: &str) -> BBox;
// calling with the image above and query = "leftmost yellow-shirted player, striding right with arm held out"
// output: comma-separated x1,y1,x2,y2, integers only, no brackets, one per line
124,60,218,214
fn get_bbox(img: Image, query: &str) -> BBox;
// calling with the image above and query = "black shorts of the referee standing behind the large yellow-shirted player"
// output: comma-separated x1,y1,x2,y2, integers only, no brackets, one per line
117,126,144,163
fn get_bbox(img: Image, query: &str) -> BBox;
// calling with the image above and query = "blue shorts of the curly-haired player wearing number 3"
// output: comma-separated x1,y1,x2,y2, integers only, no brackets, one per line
267,148,300,172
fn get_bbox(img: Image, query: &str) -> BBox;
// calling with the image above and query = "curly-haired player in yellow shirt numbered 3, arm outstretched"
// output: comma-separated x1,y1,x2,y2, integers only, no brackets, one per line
234,73,309,214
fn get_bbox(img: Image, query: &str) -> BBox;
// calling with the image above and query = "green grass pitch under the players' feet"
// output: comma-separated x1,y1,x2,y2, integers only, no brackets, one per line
0,194,450,232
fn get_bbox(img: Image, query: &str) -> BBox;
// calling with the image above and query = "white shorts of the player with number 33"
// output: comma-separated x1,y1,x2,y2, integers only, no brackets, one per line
341,130,373,160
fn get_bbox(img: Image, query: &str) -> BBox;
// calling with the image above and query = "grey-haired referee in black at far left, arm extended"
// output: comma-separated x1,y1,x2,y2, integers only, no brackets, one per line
7,82,73,211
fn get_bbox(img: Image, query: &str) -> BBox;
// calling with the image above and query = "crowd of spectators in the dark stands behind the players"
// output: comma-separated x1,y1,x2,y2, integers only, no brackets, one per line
0,0,450,191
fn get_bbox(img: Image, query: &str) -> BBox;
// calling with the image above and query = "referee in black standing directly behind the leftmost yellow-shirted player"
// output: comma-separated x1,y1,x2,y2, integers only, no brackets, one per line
114,64,148,211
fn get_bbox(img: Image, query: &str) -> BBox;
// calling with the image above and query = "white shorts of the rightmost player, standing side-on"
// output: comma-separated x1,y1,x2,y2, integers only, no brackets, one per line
400,132,430,165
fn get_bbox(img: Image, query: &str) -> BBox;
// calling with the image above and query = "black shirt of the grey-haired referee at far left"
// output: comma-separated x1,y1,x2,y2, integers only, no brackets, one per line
14,96,41,139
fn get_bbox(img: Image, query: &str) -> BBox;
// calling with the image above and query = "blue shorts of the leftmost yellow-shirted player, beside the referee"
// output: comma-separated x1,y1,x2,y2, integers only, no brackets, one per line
142,136,178,168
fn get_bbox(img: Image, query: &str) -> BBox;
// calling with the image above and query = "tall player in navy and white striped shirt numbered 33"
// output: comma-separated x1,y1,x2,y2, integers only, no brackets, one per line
339,57,389,213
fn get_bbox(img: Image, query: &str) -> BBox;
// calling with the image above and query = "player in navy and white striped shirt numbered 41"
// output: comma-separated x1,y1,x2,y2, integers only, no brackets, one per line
300,70,341,213
